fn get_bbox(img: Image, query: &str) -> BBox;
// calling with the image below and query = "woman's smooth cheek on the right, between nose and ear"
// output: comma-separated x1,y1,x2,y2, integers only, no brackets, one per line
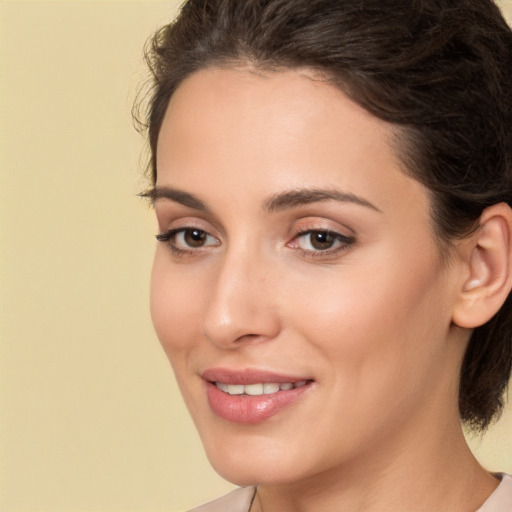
295,244,450,392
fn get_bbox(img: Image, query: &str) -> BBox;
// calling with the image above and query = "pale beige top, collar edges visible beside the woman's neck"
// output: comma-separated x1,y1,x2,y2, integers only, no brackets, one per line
189,474,512,512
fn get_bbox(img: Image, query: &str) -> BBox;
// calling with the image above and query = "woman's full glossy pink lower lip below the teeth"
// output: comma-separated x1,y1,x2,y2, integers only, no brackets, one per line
206,382,312,424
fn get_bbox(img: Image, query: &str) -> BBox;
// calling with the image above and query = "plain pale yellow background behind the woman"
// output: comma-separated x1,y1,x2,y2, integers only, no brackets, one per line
0,0,512,512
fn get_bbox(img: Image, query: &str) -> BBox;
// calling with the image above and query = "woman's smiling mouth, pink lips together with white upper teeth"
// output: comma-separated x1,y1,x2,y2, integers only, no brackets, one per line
202,369,315,424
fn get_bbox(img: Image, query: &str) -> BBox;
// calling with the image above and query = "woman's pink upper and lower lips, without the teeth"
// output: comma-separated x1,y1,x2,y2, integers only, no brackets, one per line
201,368,314,424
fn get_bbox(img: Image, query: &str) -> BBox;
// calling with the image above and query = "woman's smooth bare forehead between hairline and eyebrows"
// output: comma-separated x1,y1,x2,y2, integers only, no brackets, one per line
157,68,428,218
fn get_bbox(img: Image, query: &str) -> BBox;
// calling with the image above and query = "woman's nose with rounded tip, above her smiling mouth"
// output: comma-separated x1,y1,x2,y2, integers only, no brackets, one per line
203,247,280,349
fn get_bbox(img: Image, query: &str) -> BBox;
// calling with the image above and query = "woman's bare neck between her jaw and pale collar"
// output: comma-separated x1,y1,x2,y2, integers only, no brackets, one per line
251,418,498,512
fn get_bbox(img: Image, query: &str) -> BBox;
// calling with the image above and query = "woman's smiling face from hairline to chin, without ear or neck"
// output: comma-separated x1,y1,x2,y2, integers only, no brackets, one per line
151,69,464,485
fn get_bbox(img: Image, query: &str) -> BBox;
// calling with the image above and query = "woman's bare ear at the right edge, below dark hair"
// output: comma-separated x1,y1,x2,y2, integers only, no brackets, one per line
452,203,512,328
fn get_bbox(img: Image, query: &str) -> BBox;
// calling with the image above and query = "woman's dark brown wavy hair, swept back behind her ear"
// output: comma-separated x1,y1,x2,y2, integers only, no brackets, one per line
135,0,512,431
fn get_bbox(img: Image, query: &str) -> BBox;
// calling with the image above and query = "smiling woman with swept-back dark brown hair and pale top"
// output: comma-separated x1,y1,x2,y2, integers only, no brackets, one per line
138,0,512,512
